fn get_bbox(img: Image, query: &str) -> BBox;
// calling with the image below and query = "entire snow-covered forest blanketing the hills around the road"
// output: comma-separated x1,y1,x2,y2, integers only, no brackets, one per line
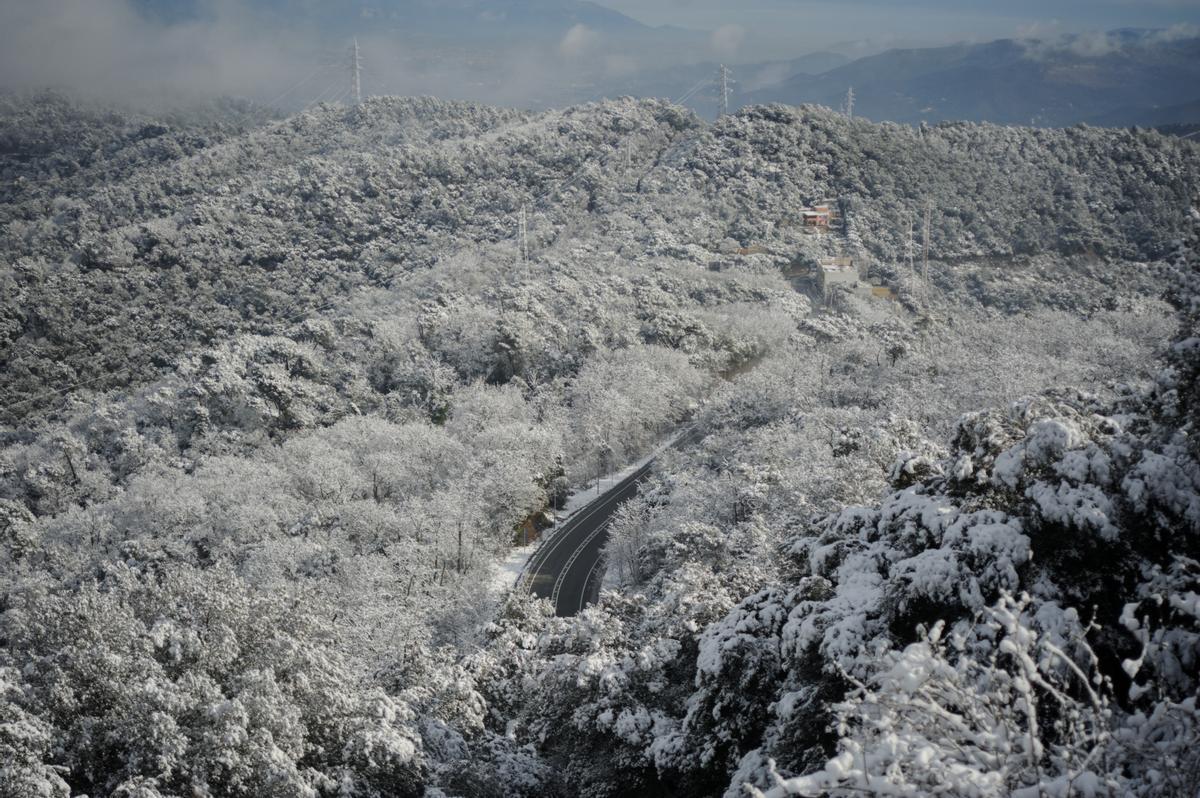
0,95,1200,798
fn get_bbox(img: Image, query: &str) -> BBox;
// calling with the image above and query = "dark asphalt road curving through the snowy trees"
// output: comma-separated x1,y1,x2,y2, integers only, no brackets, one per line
517,427,697,617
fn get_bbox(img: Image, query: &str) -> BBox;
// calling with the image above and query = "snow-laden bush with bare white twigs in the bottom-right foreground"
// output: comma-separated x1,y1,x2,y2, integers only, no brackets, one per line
750,594,1128,798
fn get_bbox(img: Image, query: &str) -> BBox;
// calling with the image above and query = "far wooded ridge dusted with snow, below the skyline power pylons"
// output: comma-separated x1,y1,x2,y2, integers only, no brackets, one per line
0,92,1195,415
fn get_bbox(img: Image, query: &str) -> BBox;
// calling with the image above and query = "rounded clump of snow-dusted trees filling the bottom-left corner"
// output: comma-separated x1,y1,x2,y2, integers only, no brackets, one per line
0,559,425,798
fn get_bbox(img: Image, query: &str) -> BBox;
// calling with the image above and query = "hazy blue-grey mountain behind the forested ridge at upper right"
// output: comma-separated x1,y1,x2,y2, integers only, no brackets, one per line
740,30,1200,125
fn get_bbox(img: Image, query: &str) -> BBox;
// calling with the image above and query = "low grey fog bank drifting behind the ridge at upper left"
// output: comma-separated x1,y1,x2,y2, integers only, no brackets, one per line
0,0,740,112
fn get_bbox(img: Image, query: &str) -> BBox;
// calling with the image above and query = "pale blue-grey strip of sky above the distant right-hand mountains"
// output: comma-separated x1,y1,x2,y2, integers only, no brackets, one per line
600,0,1200,55
